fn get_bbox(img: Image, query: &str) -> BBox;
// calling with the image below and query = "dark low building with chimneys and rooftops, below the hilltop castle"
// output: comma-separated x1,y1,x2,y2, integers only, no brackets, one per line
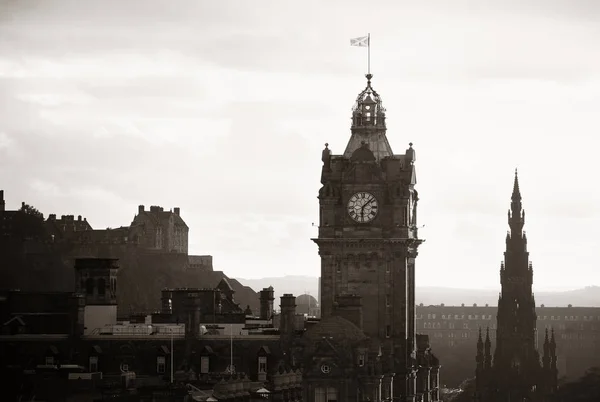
0,259,304,402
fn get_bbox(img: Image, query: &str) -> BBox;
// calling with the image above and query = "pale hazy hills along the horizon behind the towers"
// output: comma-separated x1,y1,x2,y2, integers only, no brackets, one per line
238,275,600,307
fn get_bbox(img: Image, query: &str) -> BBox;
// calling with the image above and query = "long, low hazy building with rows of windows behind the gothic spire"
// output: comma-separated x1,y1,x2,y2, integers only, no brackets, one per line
416,304,600,387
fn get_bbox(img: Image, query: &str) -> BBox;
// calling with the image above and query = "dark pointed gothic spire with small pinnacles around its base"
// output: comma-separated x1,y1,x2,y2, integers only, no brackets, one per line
477,171,556,402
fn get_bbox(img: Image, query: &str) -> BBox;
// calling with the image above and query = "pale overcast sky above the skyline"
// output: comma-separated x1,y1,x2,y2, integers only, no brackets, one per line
0,0,600,289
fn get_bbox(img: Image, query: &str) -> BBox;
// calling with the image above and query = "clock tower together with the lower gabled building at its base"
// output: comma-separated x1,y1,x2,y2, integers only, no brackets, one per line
304,74,439,402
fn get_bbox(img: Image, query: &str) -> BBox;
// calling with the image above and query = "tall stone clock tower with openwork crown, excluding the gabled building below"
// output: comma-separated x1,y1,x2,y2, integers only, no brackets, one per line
313,74,423,401
